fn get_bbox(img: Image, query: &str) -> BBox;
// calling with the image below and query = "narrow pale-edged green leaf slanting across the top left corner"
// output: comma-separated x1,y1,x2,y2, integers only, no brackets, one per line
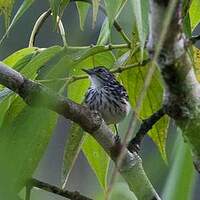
0,0,34,45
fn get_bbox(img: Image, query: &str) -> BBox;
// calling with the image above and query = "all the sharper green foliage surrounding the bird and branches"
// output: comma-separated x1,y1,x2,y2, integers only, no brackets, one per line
0,0,200,199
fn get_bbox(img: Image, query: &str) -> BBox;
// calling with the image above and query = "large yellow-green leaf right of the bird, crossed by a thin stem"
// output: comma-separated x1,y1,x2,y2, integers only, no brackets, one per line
119,53,169,160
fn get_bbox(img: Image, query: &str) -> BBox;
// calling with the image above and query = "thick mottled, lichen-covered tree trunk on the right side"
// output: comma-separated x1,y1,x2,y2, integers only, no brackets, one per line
147,0,200,171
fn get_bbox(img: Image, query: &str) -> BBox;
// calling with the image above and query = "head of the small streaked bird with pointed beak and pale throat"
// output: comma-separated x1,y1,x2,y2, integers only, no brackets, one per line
82,66,116,88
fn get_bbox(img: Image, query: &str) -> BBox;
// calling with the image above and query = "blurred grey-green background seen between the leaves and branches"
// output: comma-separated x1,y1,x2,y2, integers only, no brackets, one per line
0,1,200,200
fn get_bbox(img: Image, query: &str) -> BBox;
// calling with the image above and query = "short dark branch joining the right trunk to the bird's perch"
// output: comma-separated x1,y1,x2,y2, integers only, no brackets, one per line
128,106,165,153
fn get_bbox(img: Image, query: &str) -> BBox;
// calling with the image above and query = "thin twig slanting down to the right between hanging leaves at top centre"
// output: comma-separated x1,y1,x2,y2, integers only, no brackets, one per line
71,0,131,47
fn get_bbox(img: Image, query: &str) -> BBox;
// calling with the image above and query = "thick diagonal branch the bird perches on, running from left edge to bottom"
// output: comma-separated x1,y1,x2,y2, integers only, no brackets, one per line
0,63,160,200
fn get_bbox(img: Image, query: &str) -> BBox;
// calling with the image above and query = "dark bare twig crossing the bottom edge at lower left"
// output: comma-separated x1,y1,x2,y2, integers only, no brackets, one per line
30,179,92,200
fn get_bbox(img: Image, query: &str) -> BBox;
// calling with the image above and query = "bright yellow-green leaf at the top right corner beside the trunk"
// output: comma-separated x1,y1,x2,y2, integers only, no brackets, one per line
189,0,200,30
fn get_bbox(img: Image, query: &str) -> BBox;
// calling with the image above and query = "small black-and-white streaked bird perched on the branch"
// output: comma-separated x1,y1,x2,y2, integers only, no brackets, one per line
83,66,130,124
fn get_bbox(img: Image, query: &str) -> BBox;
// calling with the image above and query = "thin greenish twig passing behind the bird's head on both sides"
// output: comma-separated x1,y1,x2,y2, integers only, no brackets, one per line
37,59,150,85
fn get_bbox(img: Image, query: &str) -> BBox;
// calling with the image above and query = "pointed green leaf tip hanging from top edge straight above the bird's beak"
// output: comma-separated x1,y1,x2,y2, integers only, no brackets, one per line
76,2,90,31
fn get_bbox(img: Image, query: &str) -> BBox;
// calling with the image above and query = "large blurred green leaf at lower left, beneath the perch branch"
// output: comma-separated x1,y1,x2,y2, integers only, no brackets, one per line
0,97,56,193
